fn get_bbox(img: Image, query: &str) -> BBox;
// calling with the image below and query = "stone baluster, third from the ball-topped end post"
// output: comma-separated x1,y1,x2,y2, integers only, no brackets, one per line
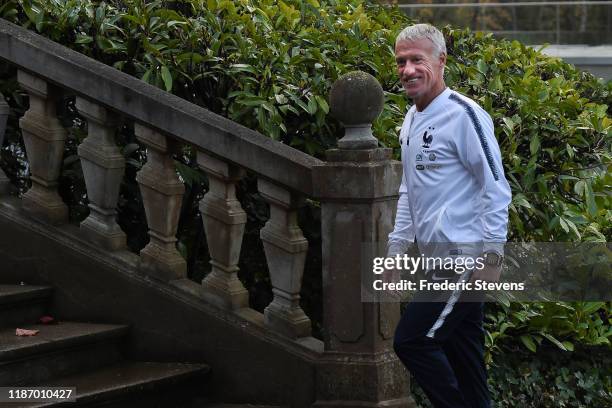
134,123,187,281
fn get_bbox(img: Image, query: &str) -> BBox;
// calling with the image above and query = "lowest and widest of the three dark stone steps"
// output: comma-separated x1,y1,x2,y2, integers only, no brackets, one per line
19,362,209,408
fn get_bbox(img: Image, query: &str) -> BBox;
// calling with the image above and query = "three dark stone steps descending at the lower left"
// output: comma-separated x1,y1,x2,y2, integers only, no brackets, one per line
0,285,209,407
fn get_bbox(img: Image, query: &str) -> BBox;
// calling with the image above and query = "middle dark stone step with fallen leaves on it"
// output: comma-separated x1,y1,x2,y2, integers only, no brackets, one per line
0,322,128,386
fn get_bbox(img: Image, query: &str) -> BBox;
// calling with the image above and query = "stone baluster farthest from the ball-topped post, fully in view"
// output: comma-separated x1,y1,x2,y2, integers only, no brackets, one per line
17,71,68,224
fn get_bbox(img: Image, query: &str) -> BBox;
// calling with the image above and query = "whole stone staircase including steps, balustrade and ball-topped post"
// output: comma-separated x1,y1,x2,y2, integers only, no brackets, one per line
0,19,416,408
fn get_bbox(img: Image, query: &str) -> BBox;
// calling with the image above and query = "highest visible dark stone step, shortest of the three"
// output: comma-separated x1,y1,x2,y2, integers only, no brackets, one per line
0,285,53,328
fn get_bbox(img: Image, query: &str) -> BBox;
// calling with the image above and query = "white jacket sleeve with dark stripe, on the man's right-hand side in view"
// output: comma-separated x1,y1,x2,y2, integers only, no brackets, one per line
458,107,512,255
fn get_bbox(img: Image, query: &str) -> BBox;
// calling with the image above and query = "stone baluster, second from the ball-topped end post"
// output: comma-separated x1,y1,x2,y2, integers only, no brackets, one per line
197,151,249,310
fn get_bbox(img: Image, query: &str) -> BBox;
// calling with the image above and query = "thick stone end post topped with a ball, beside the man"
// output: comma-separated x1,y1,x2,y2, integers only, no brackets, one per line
313,72,416,408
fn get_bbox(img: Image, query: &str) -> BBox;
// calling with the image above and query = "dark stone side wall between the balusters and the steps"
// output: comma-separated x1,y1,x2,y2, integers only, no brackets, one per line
0,198,320,408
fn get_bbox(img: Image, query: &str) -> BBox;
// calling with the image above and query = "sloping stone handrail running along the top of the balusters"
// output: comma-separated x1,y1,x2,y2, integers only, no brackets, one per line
0,19,321,196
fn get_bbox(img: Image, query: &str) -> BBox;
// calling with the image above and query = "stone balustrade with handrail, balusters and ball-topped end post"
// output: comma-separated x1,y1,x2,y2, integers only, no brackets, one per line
0,20,413,407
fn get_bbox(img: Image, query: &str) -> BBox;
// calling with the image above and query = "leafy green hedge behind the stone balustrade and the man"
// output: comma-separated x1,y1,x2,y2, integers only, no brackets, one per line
0,0,612,406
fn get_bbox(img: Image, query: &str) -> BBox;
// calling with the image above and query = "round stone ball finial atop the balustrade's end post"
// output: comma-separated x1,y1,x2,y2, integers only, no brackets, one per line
329,71,385,149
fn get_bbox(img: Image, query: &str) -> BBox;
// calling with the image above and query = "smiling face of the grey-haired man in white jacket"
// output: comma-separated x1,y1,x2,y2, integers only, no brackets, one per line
395,38,446,103
